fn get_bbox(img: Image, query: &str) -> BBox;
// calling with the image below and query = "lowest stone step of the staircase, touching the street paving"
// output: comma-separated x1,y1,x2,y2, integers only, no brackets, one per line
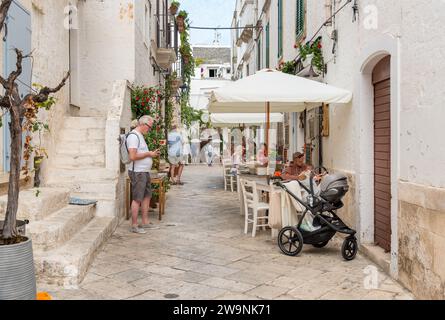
34,217,118,289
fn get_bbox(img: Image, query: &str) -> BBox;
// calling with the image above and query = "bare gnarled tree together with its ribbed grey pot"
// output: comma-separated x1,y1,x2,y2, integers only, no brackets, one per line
0,0,69,300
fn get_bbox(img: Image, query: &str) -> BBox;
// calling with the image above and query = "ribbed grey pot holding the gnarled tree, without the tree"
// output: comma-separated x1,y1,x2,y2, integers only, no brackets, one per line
0,239,37,300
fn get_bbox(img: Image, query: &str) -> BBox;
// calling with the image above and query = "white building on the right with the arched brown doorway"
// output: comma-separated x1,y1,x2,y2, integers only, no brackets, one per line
233,0,445,299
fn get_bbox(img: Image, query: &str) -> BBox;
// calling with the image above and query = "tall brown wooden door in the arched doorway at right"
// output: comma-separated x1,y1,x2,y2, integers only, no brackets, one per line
373,56,391,252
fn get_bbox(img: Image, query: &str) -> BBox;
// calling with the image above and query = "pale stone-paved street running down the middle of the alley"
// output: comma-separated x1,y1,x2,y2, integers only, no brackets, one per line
38,166,412,300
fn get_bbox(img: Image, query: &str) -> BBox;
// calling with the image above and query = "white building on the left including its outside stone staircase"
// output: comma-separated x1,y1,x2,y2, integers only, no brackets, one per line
0,0,177,286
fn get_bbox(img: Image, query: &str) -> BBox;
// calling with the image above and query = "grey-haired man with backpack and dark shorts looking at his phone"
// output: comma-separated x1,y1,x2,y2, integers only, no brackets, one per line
127,116,161,234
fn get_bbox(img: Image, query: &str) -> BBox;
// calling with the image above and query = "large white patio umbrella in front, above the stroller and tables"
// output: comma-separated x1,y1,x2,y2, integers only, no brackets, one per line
209,69,352,150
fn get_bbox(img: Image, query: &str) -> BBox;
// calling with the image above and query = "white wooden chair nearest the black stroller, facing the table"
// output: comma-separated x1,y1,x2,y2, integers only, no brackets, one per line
240,179,269,237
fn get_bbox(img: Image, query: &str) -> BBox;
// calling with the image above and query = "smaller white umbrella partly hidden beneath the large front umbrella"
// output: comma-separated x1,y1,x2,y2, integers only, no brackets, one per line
210,113,284,128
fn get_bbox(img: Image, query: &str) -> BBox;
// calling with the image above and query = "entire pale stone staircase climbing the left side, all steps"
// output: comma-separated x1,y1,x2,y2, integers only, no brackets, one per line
0,117,119,288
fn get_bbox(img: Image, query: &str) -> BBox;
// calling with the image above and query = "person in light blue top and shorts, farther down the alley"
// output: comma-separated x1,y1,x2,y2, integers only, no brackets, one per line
168,124,184,185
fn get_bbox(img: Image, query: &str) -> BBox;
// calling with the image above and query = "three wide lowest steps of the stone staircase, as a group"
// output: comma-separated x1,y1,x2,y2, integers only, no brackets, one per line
0,188,118,288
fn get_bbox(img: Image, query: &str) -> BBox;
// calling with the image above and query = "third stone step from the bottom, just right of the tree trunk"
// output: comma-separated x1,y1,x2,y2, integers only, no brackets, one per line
0,188,70,222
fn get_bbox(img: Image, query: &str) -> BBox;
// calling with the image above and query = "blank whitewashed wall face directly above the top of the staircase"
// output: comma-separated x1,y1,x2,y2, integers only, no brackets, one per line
75,0,135,116
